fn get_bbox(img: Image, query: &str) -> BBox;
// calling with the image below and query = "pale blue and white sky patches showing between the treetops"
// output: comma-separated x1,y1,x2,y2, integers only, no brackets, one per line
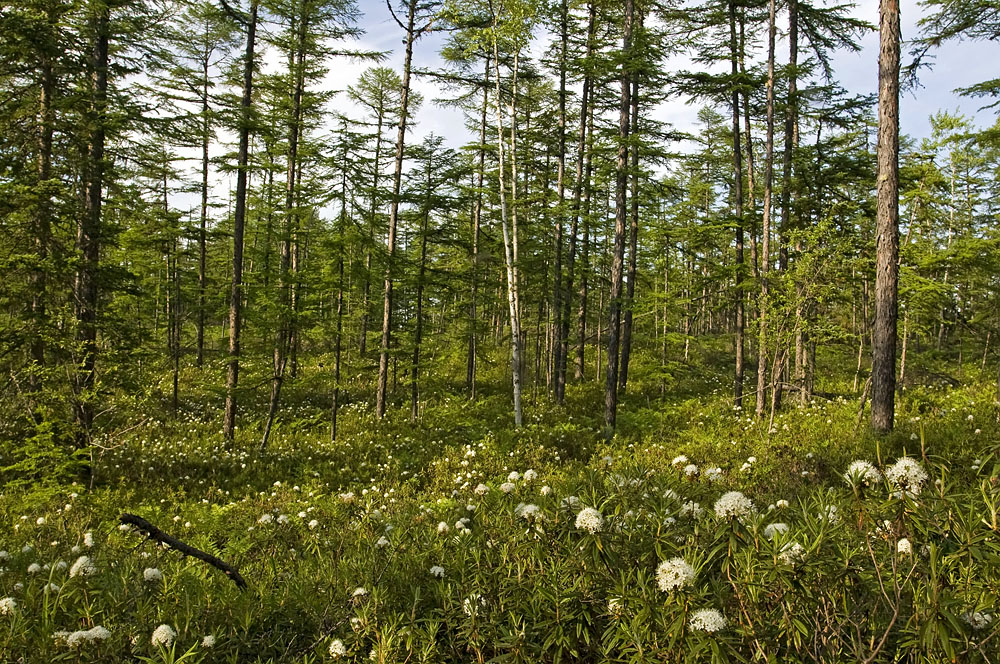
324,0,997,153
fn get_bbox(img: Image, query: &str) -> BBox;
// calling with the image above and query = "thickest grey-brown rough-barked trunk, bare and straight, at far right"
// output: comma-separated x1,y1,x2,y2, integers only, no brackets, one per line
871,0,900,433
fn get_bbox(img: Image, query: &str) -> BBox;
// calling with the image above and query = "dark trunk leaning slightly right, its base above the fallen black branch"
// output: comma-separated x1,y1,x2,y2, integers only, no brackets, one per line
222,0,257,444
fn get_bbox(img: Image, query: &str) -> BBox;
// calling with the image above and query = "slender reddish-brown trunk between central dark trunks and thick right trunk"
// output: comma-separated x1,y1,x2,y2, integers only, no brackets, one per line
755,0,776,418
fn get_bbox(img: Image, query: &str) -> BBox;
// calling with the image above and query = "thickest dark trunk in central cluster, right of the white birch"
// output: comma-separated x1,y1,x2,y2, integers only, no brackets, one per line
604,0,635,438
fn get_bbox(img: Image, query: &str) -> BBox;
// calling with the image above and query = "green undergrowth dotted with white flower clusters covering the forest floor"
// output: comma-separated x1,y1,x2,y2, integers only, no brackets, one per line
0,344,1000,664
